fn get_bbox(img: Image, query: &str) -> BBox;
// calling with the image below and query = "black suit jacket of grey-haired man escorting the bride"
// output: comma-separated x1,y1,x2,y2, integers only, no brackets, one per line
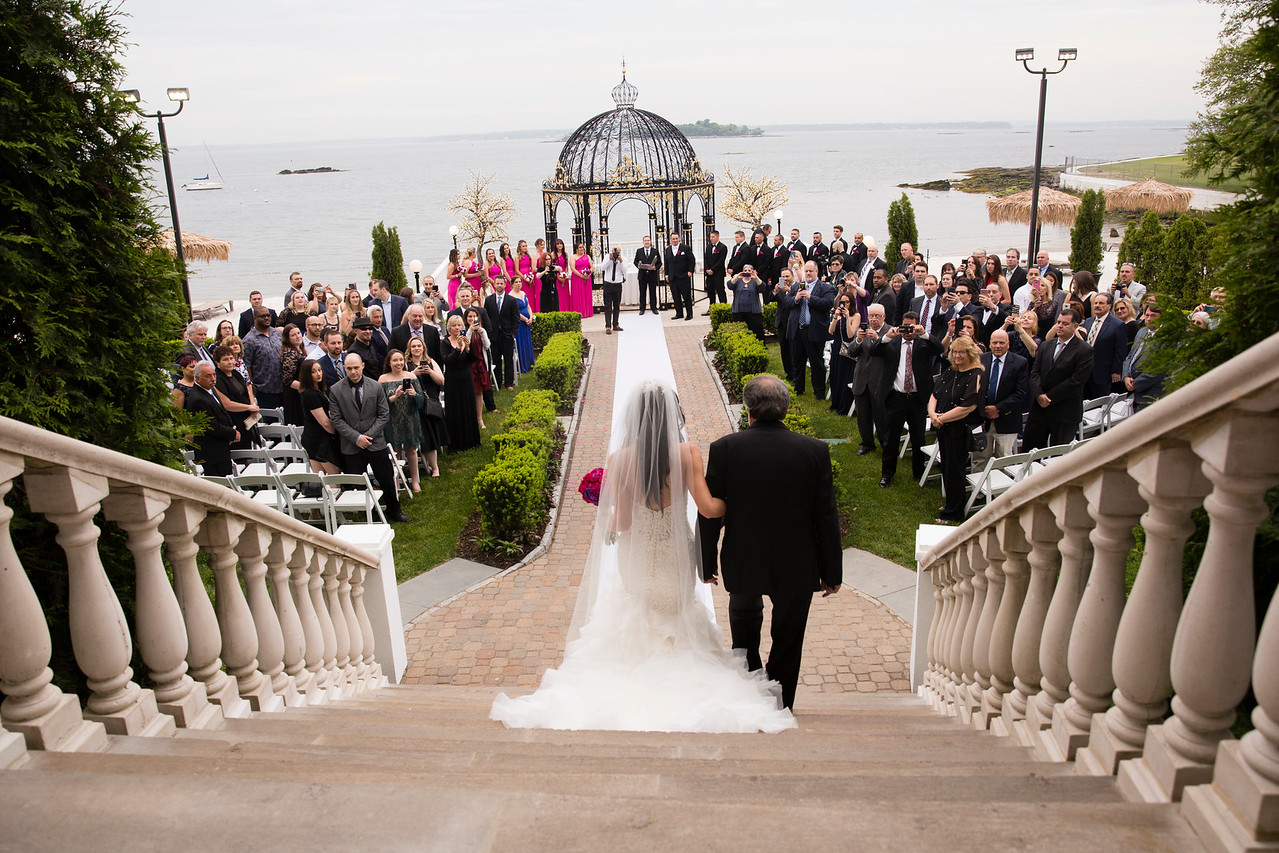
700,421,844,596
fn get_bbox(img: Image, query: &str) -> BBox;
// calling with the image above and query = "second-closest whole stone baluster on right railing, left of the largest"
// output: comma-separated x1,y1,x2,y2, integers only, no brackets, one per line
1076,440,1209,775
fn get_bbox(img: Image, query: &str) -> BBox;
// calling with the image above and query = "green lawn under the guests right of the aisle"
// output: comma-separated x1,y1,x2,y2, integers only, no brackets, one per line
767,343,943,569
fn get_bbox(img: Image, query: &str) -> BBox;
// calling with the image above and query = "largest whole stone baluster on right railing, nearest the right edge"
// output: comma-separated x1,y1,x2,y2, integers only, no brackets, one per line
1119,412,1279,802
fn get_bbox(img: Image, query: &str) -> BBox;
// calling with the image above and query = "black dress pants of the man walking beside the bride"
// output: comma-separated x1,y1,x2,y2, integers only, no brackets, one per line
728,591,812,710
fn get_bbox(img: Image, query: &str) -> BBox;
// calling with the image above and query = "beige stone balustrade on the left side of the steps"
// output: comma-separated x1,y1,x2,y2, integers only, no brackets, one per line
0,418,386,766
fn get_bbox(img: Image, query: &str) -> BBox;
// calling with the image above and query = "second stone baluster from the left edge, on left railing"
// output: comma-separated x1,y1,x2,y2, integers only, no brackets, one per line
23,467,174,735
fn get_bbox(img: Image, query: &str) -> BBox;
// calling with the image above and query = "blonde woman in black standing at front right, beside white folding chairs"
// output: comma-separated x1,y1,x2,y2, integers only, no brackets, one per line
929,335,986,522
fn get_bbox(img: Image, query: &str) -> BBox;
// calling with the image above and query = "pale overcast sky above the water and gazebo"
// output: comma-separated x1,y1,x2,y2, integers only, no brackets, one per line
123,0,1220,145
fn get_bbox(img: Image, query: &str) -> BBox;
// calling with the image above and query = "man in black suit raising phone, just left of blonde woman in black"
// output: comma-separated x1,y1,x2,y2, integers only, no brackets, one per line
871,311,943,489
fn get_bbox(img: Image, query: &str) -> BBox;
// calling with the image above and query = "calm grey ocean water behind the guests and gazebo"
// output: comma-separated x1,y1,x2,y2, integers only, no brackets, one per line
156,123,1186,302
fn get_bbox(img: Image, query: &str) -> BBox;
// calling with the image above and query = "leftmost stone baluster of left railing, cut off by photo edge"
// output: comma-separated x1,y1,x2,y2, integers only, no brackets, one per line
0,451,106,755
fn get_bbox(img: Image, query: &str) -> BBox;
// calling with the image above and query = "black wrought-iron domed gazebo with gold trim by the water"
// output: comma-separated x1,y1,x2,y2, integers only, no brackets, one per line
542,72,715,267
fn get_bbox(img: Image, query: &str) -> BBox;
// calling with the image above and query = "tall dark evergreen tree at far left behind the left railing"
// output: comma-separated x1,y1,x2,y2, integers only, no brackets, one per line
0,0,187,464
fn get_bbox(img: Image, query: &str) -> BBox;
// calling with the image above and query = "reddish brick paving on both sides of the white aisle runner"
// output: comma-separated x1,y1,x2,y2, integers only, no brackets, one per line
404,317,911,707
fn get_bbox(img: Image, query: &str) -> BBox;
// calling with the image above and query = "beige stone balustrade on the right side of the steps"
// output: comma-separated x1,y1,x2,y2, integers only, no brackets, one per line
917,336,1279,850
